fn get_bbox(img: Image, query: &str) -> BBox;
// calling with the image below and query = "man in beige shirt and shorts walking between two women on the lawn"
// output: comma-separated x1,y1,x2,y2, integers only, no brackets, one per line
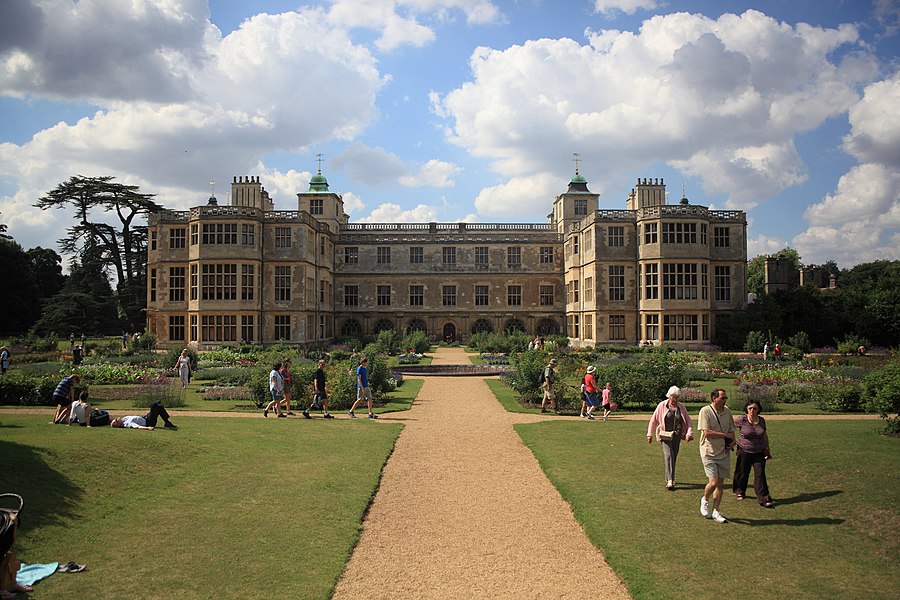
697,388,734,523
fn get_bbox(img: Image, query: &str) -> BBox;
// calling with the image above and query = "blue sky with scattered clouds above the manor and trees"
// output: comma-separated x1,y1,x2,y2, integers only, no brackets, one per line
0,0,900,268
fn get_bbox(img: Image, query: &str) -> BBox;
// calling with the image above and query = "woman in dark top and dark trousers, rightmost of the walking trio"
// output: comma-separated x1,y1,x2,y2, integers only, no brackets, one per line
732,400,775,508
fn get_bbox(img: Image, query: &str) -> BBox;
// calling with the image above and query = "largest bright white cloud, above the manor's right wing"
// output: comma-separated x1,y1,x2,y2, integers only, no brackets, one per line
431,10,877,214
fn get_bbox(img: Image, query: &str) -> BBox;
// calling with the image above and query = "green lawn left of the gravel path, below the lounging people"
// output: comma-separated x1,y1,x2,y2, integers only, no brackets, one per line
0,415,402,600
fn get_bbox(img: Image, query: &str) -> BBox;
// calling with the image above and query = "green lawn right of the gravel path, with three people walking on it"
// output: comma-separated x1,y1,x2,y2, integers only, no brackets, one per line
516,421,900,599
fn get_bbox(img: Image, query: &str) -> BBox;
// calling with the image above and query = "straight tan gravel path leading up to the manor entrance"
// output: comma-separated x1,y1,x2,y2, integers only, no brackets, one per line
326,348,629,600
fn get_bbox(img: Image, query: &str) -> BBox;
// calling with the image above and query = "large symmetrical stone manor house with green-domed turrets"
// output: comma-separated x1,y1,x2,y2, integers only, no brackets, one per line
147,169,747,347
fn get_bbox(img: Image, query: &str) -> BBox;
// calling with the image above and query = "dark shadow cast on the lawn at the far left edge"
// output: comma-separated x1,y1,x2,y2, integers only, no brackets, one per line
0,441,82,533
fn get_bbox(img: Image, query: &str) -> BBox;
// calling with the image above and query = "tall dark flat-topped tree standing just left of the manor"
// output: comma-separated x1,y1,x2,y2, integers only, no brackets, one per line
35,175,162,322
